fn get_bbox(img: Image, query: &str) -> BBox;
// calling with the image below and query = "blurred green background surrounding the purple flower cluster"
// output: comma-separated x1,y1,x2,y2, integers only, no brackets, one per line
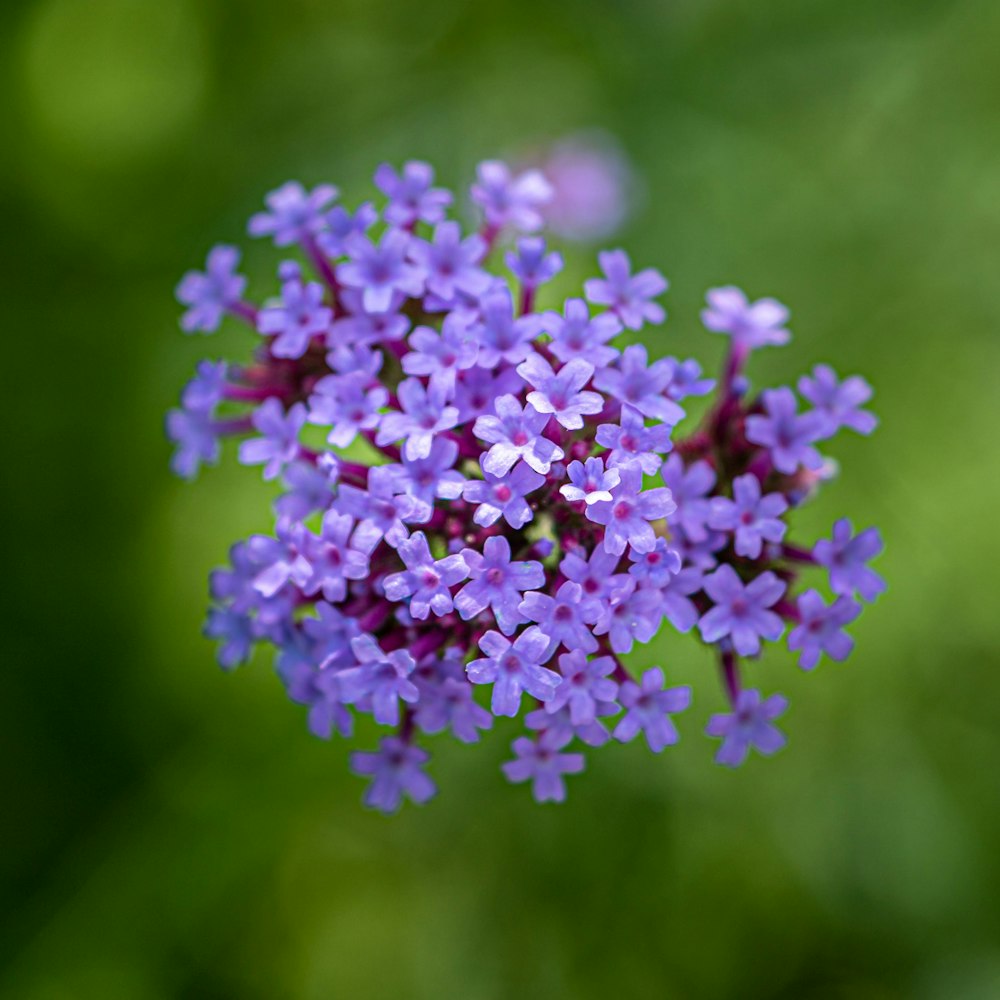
0,0,1000,1000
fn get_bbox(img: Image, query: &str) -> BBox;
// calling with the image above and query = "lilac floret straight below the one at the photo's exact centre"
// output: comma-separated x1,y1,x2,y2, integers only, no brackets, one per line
455,535,545,635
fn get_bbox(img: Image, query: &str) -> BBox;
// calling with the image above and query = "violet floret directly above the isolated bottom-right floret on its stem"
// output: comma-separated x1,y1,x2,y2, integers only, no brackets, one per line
698,563,785,656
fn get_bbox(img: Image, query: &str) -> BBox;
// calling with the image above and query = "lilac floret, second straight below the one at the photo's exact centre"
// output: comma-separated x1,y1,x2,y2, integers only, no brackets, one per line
465,626,559,717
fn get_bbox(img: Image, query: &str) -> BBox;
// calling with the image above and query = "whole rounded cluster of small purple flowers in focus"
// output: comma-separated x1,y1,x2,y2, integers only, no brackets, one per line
167,162,884,811
